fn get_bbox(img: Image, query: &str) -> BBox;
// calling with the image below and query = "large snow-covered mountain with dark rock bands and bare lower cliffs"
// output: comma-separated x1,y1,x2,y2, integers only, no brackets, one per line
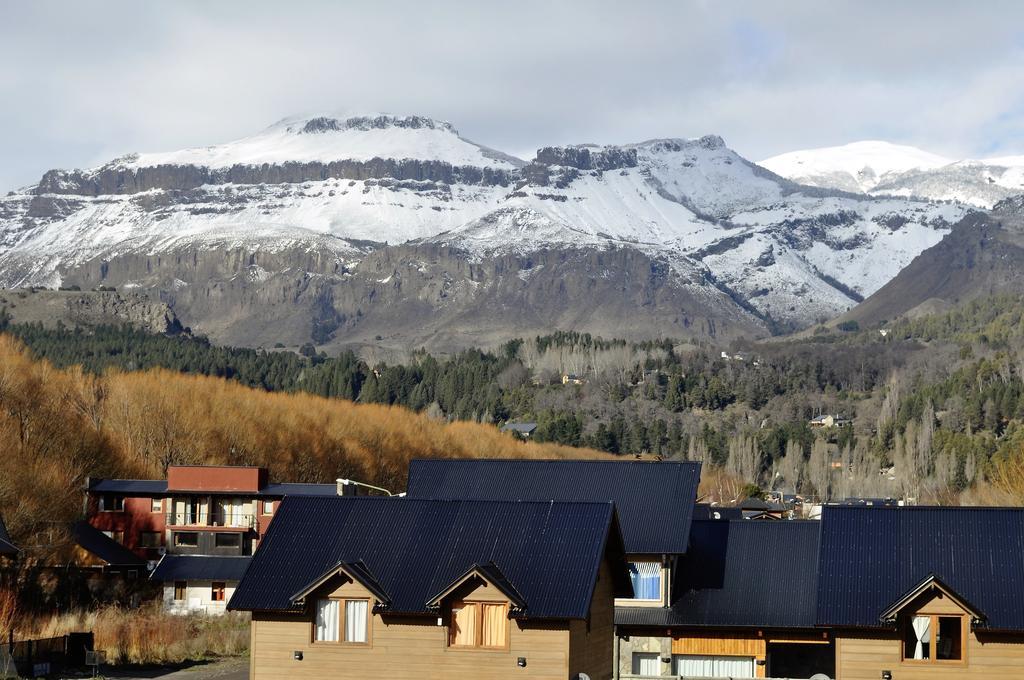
0,115,966,344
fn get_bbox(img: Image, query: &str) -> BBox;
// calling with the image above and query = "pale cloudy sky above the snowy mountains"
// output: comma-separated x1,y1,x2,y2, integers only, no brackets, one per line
0,0,1024,189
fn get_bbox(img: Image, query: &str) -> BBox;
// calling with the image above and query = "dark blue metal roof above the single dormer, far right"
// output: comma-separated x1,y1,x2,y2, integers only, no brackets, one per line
817,506,1024,631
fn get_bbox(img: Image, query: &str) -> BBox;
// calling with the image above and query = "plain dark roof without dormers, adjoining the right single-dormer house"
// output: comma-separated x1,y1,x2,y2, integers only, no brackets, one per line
615,519,820,628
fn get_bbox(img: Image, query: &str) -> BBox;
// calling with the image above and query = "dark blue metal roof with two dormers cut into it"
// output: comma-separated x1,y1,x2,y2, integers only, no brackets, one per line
229,496,632,619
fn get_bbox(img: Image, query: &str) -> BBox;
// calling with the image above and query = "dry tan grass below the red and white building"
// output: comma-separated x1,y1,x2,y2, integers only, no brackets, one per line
16,605,250,665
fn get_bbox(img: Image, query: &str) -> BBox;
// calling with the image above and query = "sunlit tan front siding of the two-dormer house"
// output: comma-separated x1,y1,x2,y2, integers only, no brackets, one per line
250,582,585,680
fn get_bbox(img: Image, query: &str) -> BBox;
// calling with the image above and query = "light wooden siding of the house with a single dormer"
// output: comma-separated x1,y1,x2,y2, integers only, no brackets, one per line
836,598,1024,680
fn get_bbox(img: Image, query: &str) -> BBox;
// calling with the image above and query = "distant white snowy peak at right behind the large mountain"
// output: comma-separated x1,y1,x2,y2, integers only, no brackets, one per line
761,141,1024,208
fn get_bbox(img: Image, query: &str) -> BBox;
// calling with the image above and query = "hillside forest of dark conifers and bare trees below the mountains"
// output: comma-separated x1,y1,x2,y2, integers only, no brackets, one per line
6,294,1024,503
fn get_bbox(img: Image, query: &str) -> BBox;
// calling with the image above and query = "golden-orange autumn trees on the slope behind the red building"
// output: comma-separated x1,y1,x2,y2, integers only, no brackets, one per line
0,336,606,538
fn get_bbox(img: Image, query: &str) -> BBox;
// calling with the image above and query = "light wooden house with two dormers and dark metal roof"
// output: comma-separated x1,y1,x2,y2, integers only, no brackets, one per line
229,497,632,680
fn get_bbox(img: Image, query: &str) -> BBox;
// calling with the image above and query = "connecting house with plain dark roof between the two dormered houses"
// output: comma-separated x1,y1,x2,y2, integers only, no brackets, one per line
615,519,835,678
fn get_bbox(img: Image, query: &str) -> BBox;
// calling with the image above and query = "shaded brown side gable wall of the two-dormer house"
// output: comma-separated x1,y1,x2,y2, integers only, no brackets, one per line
568,561,615,680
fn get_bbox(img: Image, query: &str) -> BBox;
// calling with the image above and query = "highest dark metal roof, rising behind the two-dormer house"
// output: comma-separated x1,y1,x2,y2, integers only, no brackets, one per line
409,459,700,555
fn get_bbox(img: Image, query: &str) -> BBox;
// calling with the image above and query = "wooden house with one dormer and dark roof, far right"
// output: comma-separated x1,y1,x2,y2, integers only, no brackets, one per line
816,506,1024,680
